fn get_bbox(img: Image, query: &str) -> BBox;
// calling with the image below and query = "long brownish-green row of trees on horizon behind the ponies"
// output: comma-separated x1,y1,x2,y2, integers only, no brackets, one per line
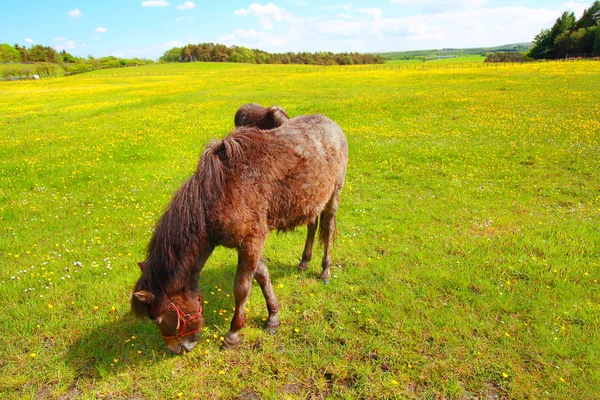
160,43,385,65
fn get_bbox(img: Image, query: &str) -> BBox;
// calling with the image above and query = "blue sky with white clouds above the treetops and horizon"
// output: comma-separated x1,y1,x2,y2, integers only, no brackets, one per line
0,0,593,59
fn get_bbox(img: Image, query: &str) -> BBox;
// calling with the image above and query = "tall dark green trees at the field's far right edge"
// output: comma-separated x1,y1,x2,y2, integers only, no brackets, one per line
528,1,600,59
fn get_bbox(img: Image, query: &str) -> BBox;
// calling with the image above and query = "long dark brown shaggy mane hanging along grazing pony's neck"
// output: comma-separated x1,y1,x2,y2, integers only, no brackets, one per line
132,128,258,315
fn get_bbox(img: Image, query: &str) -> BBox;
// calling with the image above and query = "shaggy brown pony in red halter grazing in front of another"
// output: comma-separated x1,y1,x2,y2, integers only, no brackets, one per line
131,115,348,353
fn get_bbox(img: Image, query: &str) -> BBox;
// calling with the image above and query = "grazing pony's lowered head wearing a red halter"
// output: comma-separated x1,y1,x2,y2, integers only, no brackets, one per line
131,263,204,354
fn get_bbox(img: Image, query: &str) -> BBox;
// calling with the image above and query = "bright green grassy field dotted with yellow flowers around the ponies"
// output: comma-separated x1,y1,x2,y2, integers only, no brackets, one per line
0,62,600,399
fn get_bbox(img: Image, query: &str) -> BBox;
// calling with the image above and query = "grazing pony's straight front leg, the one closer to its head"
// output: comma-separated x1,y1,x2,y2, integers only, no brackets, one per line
224,243,262,347
